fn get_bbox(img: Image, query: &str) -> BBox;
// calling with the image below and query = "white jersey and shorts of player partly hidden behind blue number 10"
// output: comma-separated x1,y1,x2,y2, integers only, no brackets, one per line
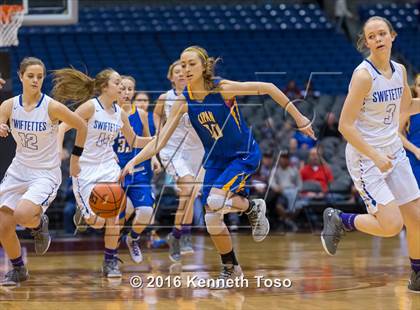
159,89,204,178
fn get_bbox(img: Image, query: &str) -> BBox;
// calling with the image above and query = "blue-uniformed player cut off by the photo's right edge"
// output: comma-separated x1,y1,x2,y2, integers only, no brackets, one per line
400,73,420,188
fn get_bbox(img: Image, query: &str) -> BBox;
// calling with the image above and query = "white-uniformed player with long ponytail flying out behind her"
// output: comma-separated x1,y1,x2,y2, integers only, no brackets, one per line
53,68,151,278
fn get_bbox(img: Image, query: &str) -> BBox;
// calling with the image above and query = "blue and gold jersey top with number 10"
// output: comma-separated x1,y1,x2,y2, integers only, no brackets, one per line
183,80,260,169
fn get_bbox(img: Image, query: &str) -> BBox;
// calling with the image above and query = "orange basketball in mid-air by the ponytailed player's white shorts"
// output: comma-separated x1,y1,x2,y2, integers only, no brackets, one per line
89,183,126,218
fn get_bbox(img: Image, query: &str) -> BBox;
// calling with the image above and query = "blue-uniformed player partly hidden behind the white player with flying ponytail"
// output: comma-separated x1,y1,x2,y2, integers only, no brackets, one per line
114,76,160,264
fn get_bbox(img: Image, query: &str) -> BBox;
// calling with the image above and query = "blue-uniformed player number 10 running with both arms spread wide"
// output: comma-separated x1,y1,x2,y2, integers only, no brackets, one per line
122,46,314,288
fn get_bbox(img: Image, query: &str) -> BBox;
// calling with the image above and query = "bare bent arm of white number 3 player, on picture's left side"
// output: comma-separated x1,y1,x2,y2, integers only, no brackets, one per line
338,69,392,172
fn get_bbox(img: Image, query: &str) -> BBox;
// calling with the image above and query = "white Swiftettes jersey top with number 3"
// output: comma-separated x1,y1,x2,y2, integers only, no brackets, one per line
355,59,404,147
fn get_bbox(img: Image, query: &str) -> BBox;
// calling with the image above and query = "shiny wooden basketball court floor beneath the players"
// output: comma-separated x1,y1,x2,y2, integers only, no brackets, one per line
0,233,420,310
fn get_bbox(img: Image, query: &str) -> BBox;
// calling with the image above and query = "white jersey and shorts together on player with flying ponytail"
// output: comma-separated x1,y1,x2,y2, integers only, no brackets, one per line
73,98,122,226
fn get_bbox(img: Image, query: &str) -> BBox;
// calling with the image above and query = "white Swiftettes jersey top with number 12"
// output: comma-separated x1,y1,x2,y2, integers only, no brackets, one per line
10,94,60,169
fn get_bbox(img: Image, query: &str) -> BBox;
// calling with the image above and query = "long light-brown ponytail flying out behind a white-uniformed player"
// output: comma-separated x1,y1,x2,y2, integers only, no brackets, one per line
51,68,116,104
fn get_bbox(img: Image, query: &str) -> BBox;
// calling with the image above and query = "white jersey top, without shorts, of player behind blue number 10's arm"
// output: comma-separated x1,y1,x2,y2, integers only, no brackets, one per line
162,89,203,153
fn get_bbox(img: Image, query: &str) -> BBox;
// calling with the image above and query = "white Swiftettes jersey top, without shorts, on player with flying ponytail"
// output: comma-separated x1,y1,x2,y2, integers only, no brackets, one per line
80,98,122,165
